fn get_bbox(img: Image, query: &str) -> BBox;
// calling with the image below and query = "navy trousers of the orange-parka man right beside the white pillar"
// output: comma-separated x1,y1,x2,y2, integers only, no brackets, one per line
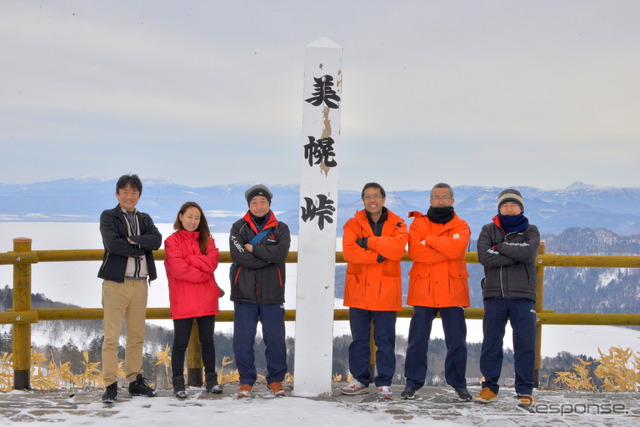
349,308,397,387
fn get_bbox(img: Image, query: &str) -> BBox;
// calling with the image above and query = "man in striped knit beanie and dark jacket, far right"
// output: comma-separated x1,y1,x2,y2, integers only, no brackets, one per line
474,189,540,407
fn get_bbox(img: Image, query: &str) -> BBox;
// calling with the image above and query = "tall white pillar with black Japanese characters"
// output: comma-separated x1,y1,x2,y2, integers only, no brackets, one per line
294,38,342,396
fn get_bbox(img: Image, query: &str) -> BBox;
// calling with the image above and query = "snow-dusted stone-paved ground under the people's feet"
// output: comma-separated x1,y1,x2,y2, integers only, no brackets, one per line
0,386,640,427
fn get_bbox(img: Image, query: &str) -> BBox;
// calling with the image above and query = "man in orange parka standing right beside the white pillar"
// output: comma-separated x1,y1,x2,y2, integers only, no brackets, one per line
340,182,409,398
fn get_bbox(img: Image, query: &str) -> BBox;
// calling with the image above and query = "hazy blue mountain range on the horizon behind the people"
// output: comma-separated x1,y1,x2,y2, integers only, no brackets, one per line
0,177,640,237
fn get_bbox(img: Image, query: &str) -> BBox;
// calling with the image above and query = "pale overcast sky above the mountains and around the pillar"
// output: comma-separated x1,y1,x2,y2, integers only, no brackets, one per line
0,0,640,190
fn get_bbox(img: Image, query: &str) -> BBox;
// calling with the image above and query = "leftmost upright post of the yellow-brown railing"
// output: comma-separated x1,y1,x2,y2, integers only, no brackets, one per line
13,237,31,390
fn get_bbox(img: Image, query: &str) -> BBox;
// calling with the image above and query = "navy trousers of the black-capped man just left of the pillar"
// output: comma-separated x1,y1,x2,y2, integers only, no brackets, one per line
233,301,287,385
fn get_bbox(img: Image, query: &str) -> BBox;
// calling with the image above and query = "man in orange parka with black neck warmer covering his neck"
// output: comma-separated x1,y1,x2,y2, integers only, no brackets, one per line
400,182,472,402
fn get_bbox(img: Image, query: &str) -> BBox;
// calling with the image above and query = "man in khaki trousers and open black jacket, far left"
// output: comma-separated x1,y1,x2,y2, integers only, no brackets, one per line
98,175,162,403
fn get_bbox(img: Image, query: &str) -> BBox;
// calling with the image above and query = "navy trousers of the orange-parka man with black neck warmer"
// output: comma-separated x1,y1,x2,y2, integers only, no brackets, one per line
404,307,467,390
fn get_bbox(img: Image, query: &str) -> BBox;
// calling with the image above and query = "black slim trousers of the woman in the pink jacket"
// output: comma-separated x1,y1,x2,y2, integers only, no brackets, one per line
171,316,216,377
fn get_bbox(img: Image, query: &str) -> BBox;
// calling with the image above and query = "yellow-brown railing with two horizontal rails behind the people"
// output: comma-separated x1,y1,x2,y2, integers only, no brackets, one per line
0,238,640,389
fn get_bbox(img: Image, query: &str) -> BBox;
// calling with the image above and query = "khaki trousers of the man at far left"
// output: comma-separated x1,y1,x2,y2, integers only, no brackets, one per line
102,279,148,387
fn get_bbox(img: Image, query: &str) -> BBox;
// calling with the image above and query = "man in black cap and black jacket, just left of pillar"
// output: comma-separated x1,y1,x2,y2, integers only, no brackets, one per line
229,185,291,397
